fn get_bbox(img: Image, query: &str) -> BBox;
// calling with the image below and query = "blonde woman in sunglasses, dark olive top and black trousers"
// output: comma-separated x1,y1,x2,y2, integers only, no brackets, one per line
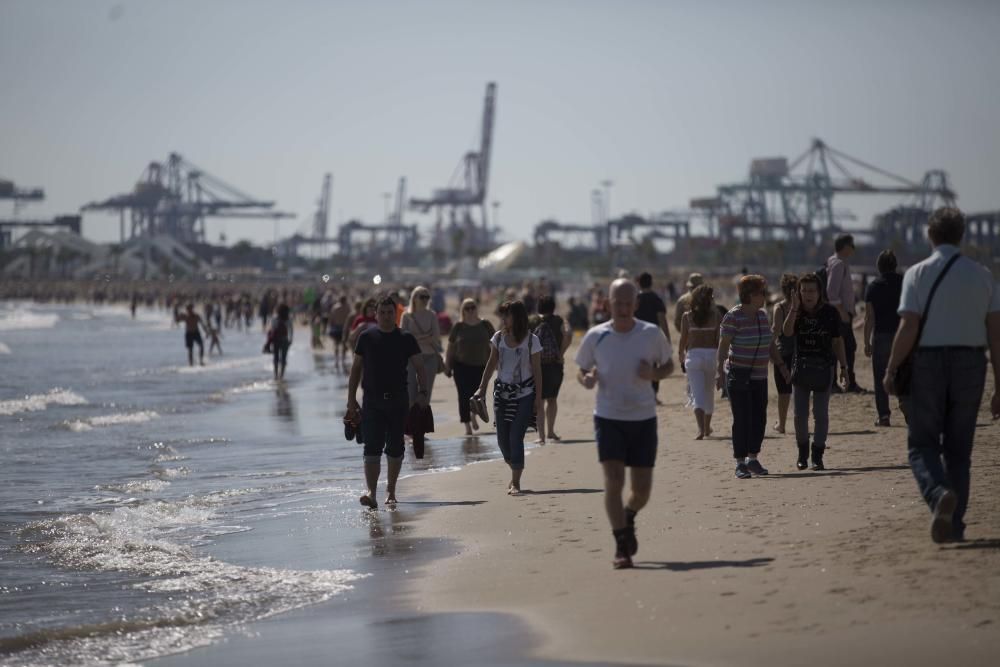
444,299,495,435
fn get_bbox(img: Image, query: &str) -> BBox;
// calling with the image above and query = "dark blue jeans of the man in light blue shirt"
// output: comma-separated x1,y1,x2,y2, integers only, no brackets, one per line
907,347,986,535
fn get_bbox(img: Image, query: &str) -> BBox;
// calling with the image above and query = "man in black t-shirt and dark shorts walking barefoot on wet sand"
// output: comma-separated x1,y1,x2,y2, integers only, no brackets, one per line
347,297,427,509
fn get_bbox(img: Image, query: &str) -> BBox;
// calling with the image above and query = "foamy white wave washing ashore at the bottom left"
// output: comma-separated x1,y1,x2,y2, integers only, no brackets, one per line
8,494,367,665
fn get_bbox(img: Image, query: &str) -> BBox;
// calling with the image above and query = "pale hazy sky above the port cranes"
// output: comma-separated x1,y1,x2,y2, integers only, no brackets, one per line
0,0,1000,244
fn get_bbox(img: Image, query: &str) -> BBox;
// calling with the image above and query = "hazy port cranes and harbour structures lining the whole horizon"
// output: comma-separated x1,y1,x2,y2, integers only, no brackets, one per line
0,82,1000,276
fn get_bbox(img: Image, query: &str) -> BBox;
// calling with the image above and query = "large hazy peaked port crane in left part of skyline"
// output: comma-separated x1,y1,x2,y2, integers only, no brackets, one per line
81,153,294,243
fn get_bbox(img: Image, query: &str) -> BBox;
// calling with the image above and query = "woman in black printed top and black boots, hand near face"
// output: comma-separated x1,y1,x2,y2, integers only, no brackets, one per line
782,273,847,470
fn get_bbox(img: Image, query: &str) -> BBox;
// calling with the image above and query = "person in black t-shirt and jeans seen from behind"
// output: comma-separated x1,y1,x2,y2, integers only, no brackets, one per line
865,250,906,426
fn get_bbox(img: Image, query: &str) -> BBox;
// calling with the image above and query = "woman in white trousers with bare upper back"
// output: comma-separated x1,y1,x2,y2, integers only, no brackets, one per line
677,285,722,440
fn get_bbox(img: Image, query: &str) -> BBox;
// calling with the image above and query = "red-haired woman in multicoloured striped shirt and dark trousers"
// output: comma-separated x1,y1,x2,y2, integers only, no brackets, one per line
716,275,771,479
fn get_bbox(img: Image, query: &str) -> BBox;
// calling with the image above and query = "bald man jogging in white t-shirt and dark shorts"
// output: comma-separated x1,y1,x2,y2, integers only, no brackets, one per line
576,278,674,570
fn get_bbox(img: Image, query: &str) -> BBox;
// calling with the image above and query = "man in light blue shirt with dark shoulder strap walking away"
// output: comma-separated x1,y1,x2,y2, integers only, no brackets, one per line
883,207,1000,543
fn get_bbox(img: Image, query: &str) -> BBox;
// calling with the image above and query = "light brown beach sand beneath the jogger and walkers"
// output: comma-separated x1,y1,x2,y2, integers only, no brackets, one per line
400,337,1000,667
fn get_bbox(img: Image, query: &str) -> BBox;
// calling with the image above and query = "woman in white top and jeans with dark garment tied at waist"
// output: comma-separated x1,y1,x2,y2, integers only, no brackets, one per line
472,301,545,496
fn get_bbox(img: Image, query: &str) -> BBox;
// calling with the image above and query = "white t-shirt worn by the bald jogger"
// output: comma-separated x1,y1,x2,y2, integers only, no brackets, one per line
576,320,673,421
